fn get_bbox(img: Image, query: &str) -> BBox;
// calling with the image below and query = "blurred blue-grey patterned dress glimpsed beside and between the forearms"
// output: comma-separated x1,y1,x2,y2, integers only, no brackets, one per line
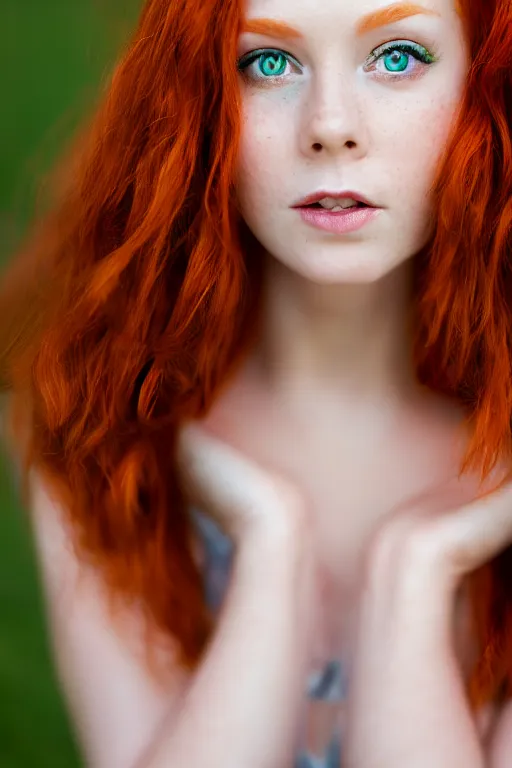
192,510,347,768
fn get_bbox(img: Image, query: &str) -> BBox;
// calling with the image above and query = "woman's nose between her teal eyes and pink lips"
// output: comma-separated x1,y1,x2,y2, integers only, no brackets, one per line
300,70,369,160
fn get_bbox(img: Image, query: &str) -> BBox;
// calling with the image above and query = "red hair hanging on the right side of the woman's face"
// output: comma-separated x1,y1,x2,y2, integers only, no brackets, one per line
415,0,512,706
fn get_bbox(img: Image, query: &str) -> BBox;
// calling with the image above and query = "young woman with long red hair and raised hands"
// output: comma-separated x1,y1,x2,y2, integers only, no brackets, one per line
0,0,512,768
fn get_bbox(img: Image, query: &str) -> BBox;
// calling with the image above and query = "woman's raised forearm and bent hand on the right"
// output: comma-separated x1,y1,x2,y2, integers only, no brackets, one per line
344,468,512,768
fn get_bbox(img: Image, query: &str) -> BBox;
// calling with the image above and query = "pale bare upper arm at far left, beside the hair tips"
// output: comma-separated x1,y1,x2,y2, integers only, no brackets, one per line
26,464,187,768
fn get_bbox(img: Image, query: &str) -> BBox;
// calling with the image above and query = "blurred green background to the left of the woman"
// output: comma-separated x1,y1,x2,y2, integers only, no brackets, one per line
0,0,142,768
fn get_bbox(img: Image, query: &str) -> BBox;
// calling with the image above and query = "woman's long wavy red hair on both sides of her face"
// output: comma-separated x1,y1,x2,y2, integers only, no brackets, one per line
0,0,512,706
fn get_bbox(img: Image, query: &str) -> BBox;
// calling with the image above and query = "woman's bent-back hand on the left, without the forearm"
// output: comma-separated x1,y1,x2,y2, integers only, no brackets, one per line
177,422,307,544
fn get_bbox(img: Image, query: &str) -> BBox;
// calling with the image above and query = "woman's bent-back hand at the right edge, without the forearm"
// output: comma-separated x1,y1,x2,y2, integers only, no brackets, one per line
366,462,512,588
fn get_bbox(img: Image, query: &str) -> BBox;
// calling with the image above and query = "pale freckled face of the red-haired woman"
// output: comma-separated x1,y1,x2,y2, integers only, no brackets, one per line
237,0,469,284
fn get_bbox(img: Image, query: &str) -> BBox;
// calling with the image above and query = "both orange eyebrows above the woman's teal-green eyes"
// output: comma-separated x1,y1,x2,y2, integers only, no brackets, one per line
242,3,440,38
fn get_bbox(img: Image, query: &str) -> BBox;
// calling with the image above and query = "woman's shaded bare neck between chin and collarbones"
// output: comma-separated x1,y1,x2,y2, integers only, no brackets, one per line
248,250,418,402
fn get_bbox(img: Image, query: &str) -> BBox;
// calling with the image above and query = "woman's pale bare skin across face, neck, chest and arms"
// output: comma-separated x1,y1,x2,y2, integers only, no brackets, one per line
16,0,512,768
